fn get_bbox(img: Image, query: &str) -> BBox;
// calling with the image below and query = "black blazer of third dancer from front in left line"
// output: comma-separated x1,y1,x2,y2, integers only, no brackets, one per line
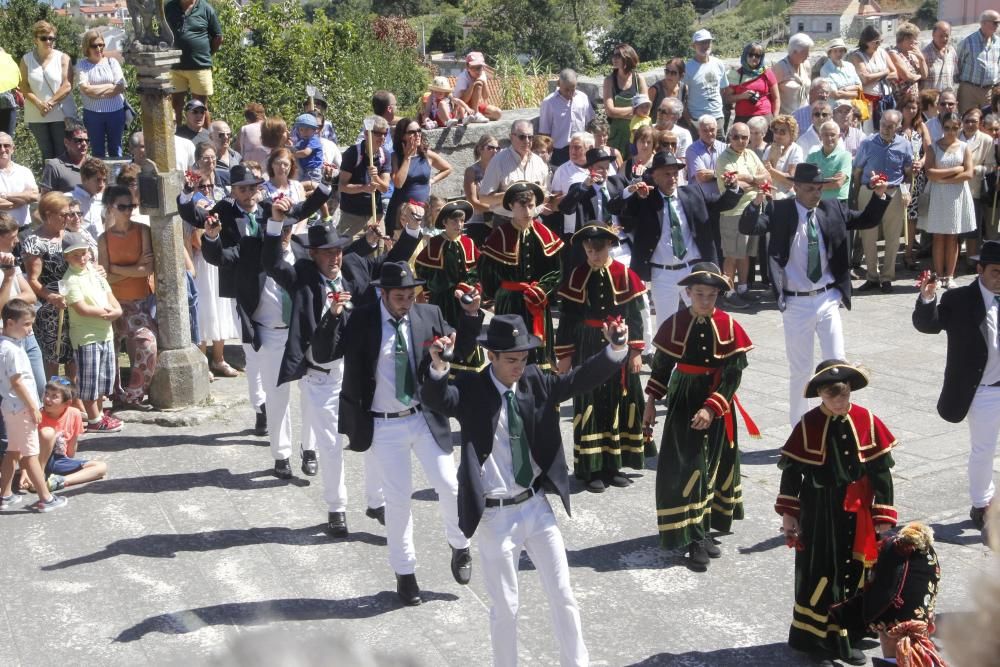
261,232,419,384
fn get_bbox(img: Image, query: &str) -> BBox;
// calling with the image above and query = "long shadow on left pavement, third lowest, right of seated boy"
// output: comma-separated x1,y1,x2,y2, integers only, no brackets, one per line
61,468,309,496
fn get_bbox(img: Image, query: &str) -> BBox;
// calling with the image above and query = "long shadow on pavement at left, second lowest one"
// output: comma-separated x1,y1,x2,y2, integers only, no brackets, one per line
41,524,386,572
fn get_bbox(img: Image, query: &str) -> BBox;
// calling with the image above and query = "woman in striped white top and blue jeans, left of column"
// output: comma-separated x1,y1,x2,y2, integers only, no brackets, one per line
76,30,125,158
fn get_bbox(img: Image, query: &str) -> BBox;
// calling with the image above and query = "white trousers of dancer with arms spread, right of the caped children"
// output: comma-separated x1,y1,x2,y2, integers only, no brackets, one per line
781,289,844,426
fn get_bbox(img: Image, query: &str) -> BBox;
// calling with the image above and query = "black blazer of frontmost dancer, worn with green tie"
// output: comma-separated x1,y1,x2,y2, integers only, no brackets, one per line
420,344,624,537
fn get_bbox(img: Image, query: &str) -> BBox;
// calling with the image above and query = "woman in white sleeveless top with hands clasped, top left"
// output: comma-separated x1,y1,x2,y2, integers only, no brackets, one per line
20,21,76,160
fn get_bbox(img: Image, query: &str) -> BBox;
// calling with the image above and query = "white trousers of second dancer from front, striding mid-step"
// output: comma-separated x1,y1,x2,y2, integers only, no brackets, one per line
371,412,469,574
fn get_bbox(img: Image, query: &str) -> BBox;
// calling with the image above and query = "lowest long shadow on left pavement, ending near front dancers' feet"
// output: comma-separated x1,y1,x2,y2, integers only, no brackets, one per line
113,590,458,643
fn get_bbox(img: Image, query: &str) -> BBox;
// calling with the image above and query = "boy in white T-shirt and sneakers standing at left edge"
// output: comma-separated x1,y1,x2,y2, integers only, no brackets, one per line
0,299,67,512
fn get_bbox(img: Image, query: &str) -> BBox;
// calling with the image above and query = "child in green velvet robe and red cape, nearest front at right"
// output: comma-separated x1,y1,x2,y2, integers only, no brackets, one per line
774,359,896,665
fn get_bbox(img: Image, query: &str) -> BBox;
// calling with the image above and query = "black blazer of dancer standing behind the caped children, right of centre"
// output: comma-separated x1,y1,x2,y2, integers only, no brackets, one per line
608,185,740,280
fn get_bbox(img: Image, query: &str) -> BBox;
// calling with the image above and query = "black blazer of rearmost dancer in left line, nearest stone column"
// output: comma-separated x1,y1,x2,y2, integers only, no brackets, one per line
177,185,330,300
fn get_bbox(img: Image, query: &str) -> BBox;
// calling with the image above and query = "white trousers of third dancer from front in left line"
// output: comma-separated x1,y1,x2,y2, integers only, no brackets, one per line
299,360,354,512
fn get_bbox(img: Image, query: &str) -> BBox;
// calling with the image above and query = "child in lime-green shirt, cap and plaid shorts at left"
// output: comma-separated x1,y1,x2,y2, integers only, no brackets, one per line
62,232,122,433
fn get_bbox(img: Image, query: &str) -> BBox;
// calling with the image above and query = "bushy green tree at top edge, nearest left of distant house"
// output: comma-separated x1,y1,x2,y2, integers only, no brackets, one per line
601,0,695,61
